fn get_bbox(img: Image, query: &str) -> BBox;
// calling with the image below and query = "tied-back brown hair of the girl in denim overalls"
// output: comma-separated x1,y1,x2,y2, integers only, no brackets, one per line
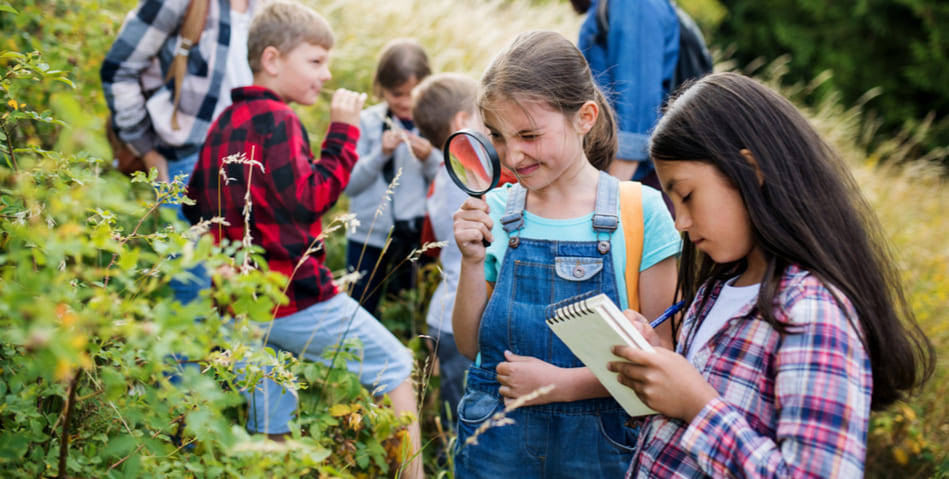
478,31,617,170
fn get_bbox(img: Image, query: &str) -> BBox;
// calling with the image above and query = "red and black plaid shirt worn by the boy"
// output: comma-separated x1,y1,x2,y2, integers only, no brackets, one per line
183,86,359,317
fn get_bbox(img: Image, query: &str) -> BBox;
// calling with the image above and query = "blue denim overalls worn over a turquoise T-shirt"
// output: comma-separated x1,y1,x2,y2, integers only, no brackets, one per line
455,173,636,479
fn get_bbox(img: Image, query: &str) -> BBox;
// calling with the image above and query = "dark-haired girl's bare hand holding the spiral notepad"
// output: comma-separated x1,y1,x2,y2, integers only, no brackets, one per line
607,346,718,422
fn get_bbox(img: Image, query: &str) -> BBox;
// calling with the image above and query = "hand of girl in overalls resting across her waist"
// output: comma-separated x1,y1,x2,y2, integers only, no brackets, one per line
495,351,561,406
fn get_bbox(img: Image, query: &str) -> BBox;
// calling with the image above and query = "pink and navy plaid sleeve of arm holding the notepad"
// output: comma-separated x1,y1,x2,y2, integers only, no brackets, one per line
682,290,872,477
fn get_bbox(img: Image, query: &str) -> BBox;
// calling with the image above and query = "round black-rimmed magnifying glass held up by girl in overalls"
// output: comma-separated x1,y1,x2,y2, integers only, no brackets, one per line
444,129,501,247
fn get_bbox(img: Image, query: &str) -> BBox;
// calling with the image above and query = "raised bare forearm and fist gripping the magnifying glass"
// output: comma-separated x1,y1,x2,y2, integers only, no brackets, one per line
451,198,494,359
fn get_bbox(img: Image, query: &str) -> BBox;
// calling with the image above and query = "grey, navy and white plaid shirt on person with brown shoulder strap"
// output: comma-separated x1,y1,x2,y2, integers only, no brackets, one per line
100,0,255,161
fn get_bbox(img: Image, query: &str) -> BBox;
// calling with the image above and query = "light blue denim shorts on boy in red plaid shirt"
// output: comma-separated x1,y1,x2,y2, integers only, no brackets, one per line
239,293,412,434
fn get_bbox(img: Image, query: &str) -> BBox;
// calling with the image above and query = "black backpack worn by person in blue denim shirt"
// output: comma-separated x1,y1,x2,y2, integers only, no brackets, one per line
595,0,714,93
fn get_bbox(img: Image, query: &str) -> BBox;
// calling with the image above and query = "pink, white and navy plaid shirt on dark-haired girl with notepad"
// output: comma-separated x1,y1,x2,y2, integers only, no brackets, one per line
627,266,873,478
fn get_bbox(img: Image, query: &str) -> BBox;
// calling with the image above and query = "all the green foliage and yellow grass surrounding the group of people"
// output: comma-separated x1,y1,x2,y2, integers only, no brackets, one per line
0,0,949,477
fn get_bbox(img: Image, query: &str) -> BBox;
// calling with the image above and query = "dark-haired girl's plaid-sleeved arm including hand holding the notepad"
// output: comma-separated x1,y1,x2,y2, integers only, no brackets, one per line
611,298,872,477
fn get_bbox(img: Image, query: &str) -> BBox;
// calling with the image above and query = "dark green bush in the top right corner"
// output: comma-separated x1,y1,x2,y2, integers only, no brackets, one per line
708,0,949,162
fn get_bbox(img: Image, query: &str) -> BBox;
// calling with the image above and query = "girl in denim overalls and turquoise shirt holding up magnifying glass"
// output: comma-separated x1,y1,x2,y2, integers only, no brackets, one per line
452,32,681,478
